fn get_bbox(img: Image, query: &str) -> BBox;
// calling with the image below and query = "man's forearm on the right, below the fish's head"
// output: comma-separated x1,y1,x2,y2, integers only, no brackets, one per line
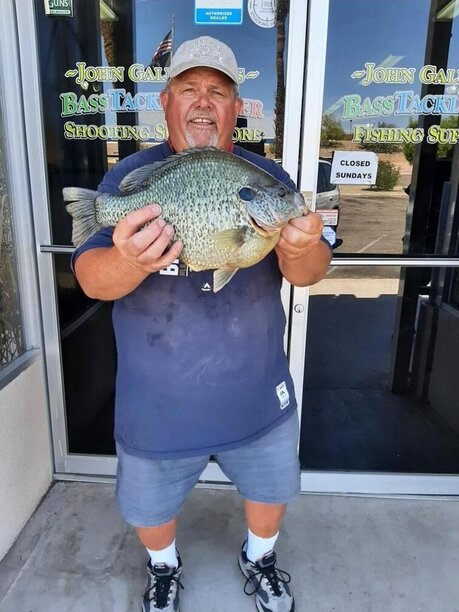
279,242,331,287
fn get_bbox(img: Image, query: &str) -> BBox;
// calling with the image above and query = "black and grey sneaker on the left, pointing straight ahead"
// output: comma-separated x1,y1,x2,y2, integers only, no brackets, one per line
142,555,183,612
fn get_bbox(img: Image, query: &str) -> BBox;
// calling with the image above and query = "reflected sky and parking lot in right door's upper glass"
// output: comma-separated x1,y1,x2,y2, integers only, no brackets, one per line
317,0,459,255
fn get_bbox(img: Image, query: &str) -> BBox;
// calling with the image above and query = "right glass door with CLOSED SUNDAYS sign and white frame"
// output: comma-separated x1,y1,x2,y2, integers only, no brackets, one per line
290,0,459,494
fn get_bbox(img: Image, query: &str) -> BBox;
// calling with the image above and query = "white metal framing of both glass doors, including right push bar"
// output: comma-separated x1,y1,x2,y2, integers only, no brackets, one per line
17,0,459,495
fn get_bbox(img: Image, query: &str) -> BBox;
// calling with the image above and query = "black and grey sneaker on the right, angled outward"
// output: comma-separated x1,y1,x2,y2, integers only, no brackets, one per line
239,540,295,612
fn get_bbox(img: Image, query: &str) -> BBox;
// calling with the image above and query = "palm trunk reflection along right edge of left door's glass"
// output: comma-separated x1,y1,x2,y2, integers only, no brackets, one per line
274,0,289,157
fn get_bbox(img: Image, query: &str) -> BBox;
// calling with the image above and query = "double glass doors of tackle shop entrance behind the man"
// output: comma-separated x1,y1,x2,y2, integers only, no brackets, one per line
18,0,459,493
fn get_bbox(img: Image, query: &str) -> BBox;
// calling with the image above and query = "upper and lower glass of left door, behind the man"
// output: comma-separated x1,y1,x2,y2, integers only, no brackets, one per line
35,0,290,454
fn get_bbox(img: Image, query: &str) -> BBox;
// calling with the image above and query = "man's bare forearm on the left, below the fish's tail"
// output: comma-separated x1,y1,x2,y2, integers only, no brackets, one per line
75,247,148,300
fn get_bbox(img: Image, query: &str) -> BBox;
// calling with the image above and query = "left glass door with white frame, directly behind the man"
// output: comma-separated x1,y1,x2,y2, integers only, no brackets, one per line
19,0,307,480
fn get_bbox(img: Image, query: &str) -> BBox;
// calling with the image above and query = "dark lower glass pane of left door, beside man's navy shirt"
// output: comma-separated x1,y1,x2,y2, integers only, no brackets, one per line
53,255,116,455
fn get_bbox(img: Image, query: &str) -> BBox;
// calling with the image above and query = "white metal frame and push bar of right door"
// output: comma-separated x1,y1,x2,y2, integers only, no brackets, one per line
289,0,459,495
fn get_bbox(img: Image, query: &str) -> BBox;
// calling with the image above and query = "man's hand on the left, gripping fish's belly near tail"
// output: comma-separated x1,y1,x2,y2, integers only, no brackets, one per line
113,204,183,273
